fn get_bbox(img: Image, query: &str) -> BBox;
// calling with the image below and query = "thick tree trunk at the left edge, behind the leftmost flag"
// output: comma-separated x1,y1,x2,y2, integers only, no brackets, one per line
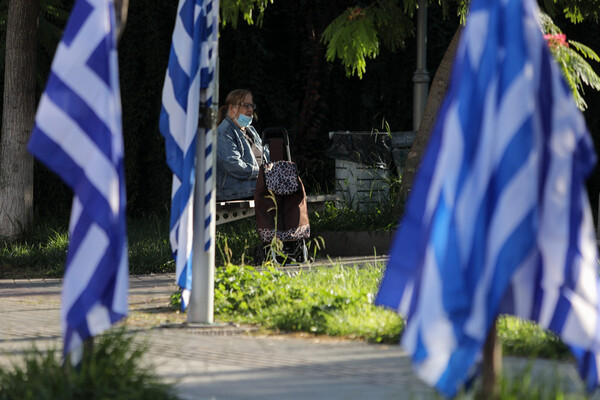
0,0,39,239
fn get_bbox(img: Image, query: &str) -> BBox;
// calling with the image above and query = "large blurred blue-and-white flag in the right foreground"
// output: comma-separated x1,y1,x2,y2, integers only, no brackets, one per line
376,0,600,396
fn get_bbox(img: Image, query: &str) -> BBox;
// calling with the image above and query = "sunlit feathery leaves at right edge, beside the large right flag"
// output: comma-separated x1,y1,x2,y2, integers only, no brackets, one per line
540,13,600,111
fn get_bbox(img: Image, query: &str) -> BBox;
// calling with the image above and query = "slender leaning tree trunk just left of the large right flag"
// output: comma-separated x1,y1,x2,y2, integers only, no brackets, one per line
395,25,462,216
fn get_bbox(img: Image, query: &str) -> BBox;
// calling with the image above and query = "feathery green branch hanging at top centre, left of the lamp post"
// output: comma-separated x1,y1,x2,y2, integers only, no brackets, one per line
321,0,414,79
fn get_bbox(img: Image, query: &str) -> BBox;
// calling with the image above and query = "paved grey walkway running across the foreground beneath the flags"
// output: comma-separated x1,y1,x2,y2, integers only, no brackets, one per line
0,258,596,400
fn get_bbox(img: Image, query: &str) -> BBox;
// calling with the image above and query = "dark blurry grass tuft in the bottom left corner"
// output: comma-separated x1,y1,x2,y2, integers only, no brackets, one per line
0,331,177,400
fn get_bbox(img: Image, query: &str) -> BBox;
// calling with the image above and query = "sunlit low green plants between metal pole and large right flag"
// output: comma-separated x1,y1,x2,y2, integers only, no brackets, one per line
215,265,404,343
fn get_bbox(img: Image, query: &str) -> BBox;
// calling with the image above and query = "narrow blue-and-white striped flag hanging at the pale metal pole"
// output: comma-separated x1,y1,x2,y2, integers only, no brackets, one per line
160,0,219,309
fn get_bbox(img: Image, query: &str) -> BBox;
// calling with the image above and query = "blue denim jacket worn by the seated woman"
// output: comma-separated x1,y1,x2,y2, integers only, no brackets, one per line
217,117,269,200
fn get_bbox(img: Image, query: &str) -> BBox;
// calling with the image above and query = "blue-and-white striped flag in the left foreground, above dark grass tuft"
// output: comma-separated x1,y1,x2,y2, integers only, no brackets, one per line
28,0,128,363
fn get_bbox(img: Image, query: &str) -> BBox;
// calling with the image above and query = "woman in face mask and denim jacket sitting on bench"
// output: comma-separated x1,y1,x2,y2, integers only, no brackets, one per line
217,89,269,201
